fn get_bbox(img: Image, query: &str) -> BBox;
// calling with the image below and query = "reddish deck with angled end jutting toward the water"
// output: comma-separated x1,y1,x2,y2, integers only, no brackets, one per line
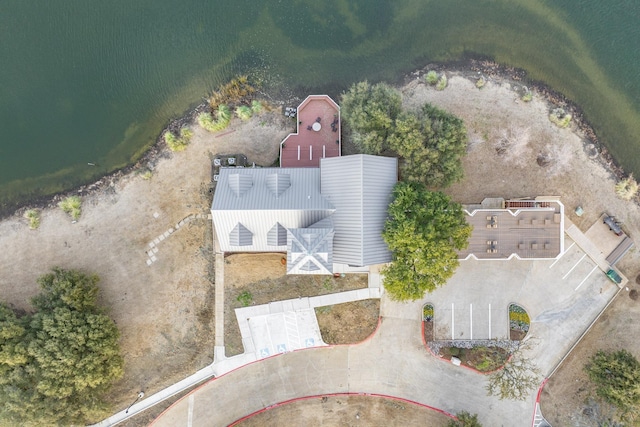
280,95,341,168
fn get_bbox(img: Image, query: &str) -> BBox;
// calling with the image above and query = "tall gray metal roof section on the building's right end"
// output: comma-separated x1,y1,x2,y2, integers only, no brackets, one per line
320,154,398,266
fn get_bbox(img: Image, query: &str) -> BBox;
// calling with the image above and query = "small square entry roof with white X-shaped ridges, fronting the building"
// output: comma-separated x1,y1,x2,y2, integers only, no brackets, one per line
287,228,334,274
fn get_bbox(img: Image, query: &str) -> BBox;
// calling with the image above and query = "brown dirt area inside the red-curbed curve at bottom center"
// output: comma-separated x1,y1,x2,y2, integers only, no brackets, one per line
234,396,450,427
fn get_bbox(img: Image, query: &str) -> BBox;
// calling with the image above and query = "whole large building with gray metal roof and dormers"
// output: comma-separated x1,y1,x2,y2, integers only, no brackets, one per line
211,154,398,274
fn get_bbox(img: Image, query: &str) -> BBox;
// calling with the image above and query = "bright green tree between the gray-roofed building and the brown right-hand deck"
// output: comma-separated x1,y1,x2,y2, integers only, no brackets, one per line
382,182,471,301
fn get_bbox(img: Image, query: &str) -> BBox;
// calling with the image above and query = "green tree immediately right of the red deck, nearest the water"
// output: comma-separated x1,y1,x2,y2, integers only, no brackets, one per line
340,81,402,154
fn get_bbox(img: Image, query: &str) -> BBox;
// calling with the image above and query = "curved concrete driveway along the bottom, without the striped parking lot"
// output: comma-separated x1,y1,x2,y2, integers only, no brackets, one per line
153,317,535,427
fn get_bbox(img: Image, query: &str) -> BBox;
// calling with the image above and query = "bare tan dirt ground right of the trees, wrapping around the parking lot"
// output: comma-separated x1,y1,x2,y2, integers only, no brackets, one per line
403,73,640,426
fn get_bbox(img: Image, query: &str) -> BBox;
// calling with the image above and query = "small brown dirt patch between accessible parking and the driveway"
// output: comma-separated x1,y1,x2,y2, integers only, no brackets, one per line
316,299,380,344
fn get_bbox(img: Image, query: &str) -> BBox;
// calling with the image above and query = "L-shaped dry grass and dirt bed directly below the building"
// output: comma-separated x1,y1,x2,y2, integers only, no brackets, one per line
224,253,364,356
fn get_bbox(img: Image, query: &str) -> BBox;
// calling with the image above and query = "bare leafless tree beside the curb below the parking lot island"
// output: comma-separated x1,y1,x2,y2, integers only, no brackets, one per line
486,343,540,400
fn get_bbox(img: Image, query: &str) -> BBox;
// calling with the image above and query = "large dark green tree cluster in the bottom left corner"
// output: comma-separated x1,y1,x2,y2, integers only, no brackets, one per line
0,268,123,425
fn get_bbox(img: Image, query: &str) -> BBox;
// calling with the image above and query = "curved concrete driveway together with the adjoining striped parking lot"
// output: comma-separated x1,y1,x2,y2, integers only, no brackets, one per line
153,249,619,427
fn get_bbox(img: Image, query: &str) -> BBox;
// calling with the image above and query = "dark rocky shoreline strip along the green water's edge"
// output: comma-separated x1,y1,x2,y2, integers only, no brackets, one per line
0,58,637,220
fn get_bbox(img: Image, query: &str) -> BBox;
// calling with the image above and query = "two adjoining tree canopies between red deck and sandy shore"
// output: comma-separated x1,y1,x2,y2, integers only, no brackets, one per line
341,82,468,188
